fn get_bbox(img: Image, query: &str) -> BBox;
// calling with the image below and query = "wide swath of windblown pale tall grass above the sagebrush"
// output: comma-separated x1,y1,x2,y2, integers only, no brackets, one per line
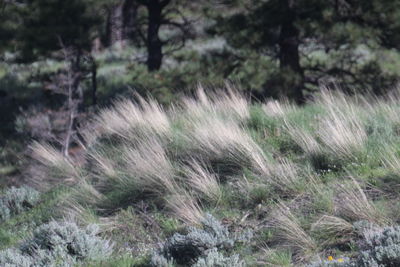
32,86,400,264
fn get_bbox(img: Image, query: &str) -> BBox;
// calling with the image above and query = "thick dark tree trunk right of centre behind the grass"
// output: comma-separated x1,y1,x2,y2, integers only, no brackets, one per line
278,0,304,103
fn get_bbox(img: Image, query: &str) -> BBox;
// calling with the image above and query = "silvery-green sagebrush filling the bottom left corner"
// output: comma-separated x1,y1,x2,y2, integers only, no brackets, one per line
0,222,112,266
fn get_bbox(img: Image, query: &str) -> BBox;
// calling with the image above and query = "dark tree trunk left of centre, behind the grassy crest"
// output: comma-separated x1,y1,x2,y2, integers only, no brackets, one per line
147,0,163,71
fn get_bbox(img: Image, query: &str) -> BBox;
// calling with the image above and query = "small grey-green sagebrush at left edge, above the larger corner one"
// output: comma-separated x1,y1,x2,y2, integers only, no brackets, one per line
0,187,40,221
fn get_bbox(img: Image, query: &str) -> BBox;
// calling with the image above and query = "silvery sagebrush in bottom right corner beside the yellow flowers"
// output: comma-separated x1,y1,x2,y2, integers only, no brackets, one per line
358,226,400,267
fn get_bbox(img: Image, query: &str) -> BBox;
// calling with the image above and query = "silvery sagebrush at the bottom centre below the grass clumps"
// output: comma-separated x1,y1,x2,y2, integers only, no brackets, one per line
151,214,252,266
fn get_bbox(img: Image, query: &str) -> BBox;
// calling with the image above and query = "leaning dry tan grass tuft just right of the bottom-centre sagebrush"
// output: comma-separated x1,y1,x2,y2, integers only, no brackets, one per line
272,203,316,261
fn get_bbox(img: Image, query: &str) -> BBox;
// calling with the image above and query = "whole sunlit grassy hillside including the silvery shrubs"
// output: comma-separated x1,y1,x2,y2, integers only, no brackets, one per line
0,86,400,266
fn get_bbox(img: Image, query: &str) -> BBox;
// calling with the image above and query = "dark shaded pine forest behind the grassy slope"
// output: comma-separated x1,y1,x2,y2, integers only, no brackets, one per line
0,0,400,182
